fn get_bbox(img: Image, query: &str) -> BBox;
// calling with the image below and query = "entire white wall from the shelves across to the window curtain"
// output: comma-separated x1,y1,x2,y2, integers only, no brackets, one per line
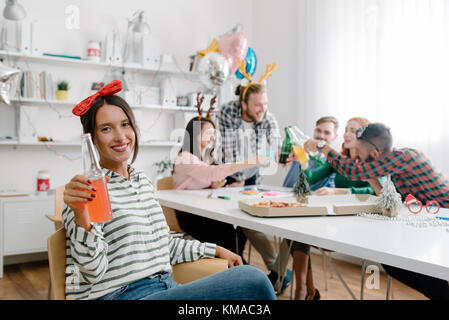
0,0,304,192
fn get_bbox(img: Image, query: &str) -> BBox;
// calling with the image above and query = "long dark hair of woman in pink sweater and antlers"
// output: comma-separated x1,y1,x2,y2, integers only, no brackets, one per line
179,117,215,160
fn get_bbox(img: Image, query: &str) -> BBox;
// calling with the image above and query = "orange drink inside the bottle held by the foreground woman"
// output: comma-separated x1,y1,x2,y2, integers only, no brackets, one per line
87,177,112,222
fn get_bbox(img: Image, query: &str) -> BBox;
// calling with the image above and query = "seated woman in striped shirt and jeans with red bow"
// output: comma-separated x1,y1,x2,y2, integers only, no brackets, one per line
62,84,275,300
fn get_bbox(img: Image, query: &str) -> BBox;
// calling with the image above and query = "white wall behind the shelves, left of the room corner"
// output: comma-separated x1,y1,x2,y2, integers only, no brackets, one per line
0,0,253,192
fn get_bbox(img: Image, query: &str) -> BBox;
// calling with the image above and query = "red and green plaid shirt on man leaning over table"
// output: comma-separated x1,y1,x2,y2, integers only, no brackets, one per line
327,148,449,208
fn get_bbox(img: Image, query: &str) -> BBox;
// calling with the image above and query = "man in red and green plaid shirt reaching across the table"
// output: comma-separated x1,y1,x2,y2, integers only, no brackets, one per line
304,123,449,299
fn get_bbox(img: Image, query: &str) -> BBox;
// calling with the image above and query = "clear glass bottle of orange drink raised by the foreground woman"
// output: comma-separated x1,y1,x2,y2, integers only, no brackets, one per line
81,133,112,223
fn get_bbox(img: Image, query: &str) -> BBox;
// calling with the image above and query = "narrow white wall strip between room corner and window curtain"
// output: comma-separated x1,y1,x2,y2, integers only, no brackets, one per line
252,0,302,185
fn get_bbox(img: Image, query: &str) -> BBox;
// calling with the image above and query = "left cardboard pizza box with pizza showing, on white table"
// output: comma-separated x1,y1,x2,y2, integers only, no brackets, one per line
239,197,328,217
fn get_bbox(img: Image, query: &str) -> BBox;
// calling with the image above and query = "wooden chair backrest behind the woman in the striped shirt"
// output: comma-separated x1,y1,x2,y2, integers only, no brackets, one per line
47,228,66,300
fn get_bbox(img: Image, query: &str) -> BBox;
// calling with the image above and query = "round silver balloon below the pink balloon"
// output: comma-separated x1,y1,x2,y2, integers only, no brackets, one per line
198,52,231,89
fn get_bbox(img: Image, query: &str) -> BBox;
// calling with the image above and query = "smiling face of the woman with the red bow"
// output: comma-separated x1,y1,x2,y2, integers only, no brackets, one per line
94,104,136,167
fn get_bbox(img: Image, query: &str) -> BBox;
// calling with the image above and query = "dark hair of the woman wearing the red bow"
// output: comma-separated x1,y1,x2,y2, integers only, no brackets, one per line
80,95,139,163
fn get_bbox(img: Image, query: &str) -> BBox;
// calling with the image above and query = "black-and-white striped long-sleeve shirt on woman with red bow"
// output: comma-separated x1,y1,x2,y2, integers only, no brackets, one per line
62,168,216,299
